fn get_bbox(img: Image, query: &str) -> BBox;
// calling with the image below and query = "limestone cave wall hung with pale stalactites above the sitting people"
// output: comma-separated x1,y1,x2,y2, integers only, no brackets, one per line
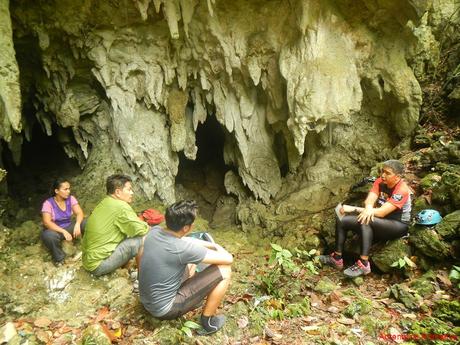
0,0,448,207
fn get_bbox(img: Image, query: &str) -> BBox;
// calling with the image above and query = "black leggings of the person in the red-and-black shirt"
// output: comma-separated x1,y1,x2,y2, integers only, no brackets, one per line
335,216,409,256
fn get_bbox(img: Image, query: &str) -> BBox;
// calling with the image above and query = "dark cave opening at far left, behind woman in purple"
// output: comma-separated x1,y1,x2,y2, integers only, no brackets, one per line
1,123,82,225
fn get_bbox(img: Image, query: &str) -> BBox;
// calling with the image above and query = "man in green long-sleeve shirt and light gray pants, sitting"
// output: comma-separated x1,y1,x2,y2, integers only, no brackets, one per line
82,174,149,276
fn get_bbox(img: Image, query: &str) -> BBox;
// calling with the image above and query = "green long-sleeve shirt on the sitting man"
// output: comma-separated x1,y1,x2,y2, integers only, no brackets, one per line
82,196,149,271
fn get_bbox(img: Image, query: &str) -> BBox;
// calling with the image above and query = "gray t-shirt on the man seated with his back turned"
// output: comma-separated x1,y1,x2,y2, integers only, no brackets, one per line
139,226,207,317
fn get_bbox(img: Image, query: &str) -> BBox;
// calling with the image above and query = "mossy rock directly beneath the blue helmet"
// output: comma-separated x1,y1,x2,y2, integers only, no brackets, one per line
409,225,450,260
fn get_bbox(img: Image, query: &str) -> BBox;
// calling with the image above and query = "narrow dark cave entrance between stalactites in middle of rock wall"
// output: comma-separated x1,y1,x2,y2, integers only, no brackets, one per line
176,116,230,221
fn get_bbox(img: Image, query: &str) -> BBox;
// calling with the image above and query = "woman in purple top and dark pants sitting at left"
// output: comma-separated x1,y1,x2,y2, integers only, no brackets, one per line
41,178,84,265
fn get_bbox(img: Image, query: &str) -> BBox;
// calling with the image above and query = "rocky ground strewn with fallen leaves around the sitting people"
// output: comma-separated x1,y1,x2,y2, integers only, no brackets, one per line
0,215,460,345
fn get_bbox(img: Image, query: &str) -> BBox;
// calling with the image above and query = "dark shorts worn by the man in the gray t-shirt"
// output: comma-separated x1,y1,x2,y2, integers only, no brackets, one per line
159,265,223,320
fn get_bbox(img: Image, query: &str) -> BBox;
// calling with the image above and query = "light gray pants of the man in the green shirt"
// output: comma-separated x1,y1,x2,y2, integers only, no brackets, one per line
91,236,143,277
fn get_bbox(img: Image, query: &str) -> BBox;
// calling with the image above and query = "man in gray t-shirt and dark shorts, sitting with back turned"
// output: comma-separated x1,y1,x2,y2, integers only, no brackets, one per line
139,200,233,334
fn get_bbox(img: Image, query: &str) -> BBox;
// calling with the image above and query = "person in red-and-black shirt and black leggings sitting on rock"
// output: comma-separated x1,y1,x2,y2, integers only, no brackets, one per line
319,160,411,277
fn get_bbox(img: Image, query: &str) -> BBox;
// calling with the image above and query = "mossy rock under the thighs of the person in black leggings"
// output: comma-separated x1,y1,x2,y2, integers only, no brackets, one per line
372,238,411,273
